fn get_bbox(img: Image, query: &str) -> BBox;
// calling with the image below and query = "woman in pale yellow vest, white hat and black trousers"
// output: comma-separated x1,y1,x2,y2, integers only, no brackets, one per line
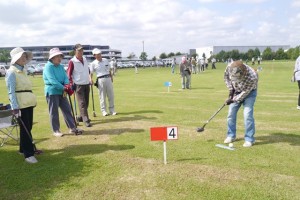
5,47,41,163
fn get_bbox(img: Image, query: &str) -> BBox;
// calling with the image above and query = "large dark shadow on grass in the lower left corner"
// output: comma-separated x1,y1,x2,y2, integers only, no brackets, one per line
0,144,135,199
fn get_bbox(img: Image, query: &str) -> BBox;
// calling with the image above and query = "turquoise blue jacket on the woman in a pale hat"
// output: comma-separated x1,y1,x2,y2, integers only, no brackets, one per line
43,61,69,96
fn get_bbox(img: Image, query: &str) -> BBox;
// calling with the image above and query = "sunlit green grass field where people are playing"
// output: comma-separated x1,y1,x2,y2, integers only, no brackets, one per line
0,61,300,200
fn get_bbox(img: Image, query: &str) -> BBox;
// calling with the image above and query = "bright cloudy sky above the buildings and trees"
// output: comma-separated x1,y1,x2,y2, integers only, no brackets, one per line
0,0,300,58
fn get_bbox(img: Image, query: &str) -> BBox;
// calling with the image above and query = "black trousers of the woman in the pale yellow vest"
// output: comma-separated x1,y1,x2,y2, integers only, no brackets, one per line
19,107,34,158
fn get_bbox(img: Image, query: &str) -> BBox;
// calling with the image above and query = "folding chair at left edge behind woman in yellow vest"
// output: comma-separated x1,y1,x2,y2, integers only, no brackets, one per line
0,109,19,147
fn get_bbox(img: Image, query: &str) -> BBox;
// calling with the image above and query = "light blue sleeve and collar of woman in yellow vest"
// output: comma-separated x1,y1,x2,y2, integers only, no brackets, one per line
5,64,24,110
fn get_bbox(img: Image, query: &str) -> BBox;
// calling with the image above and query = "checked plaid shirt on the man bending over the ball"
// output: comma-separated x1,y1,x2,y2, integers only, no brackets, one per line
224,65,258,103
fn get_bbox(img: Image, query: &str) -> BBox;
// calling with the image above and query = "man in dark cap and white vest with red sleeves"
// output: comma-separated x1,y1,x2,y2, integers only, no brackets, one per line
67,44,92,127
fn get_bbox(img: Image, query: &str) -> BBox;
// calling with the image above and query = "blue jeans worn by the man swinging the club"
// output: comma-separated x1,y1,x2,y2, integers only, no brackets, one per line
227,90,257,143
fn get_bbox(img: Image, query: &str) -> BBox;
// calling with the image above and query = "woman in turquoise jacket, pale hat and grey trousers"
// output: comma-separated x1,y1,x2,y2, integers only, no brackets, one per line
43,48,82,137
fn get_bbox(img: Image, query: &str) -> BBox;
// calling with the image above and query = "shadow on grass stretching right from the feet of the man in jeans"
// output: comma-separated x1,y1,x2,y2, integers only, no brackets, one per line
255,133,300,146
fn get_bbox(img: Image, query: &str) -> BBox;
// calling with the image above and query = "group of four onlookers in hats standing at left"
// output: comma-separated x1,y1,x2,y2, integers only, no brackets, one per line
5,44,117,163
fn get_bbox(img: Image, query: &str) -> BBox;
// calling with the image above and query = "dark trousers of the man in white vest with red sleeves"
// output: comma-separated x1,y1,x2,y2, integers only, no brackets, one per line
76,85,90,122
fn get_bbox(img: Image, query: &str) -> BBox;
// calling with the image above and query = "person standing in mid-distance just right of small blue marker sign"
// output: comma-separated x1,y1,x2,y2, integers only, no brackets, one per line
179,56,191,89
